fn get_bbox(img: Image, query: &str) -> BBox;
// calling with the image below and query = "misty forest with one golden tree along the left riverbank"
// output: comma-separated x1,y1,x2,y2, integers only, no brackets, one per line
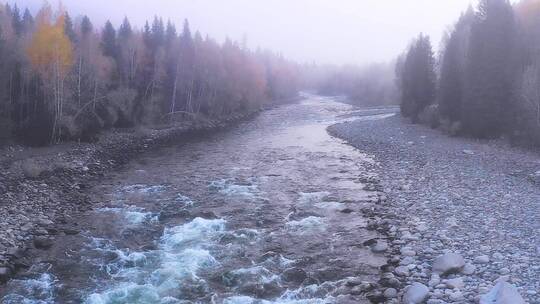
0,4,298,145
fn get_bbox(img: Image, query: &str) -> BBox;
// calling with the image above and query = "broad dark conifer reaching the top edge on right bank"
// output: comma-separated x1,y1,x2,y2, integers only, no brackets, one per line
461,0,515,138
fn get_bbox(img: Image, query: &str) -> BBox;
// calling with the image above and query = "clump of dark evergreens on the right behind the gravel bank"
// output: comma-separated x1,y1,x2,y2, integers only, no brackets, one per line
396,0,540,145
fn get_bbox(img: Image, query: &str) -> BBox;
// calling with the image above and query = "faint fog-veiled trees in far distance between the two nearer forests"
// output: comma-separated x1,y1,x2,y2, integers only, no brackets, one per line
302,64,399,106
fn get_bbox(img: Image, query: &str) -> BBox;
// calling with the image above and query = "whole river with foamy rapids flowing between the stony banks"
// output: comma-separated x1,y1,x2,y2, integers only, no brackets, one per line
2,96,385,304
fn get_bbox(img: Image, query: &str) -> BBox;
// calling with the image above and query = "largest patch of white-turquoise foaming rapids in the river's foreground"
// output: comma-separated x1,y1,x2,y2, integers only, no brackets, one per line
85,218,226,304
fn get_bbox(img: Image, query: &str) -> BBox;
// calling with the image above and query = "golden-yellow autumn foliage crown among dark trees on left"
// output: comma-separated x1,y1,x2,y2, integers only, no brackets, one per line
27,13,73,77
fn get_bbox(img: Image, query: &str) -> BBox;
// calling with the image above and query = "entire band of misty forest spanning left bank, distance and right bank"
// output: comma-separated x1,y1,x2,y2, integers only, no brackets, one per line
0,0,540,145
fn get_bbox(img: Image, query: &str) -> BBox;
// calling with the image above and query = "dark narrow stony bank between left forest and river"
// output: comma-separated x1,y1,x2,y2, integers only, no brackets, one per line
0,111,264,282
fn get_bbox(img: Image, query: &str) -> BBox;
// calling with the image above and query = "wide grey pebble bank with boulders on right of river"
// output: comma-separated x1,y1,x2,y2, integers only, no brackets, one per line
329,116,540,304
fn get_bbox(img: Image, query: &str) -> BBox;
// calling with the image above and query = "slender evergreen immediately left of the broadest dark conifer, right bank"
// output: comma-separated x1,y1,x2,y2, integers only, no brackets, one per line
438,7,474,122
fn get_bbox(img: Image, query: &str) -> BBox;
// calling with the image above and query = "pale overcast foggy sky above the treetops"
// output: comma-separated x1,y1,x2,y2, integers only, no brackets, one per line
9,0,476,64
